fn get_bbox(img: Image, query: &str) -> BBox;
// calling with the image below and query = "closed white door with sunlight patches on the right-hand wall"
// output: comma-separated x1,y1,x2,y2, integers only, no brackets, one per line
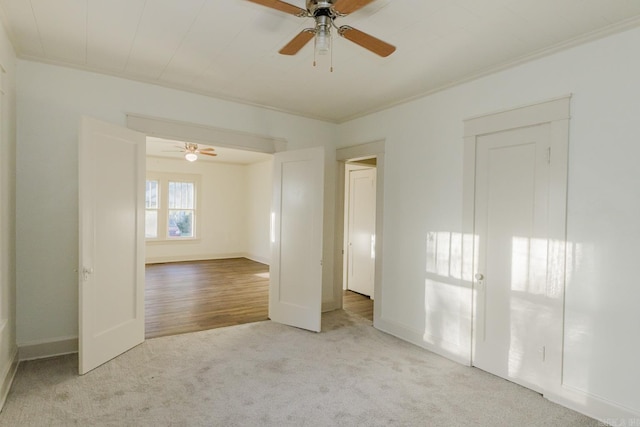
474,125,550,391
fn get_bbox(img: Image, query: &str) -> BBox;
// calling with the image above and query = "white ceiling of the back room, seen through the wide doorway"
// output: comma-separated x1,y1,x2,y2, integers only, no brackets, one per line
147,137,272,165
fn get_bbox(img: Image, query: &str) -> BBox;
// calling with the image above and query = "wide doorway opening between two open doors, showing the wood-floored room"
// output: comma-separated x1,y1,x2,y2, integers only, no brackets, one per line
145,137,273,338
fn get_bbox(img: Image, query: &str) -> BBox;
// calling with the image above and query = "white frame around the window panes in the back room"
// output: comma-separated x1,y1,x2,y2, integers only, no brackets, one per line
145,171,201,244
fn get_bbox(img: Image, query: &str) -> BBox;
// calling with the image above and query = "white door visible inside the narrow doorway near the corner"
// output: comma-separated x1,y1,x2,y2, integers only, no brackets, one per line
347,168,376,297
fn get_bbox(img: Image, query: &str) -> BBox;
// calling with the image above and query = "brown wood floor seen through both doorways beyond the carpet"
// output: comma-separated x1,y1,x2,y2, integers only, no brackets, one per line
145,258,373,338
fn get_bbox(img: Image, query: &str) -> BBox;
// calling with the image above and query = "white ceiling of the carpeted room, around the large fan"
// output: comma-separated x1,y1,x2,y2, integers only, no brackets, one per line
0,0,640,122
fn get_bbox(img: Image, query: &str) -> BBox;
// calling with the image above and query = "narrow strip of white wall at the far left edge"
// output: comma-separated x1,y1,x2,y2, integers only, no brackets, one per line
0,17,17,409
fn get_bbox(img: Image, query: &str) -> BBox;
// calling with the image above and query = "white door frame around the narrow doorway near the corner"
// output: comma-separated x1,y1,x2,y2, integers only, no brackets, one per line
333,140,385,327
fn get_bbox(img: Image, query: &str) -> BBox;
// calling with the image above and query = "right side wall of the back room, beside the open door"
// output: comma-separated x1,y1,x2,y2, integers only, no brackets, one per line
246,160,273,264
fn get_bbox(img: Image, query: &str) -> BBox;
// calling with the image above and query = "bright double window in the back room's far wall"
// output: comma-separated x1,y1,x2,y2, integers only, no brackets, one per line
145,173,199,241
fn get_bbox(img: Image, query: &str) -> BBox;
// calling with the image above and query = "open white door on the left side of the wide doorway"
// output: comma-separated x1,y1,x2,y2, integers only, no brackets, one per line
78,117,145,374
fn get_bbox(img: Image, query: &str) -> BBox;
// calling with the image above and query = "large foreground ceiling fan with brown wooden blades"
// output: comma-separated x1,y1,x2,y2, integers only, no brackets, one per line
249,0,396,57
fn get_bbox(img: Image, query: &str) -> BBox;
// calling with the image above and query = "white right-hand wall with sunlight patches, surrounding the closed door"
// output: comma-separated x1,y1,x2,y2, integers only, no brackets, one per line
340,25,640,419
